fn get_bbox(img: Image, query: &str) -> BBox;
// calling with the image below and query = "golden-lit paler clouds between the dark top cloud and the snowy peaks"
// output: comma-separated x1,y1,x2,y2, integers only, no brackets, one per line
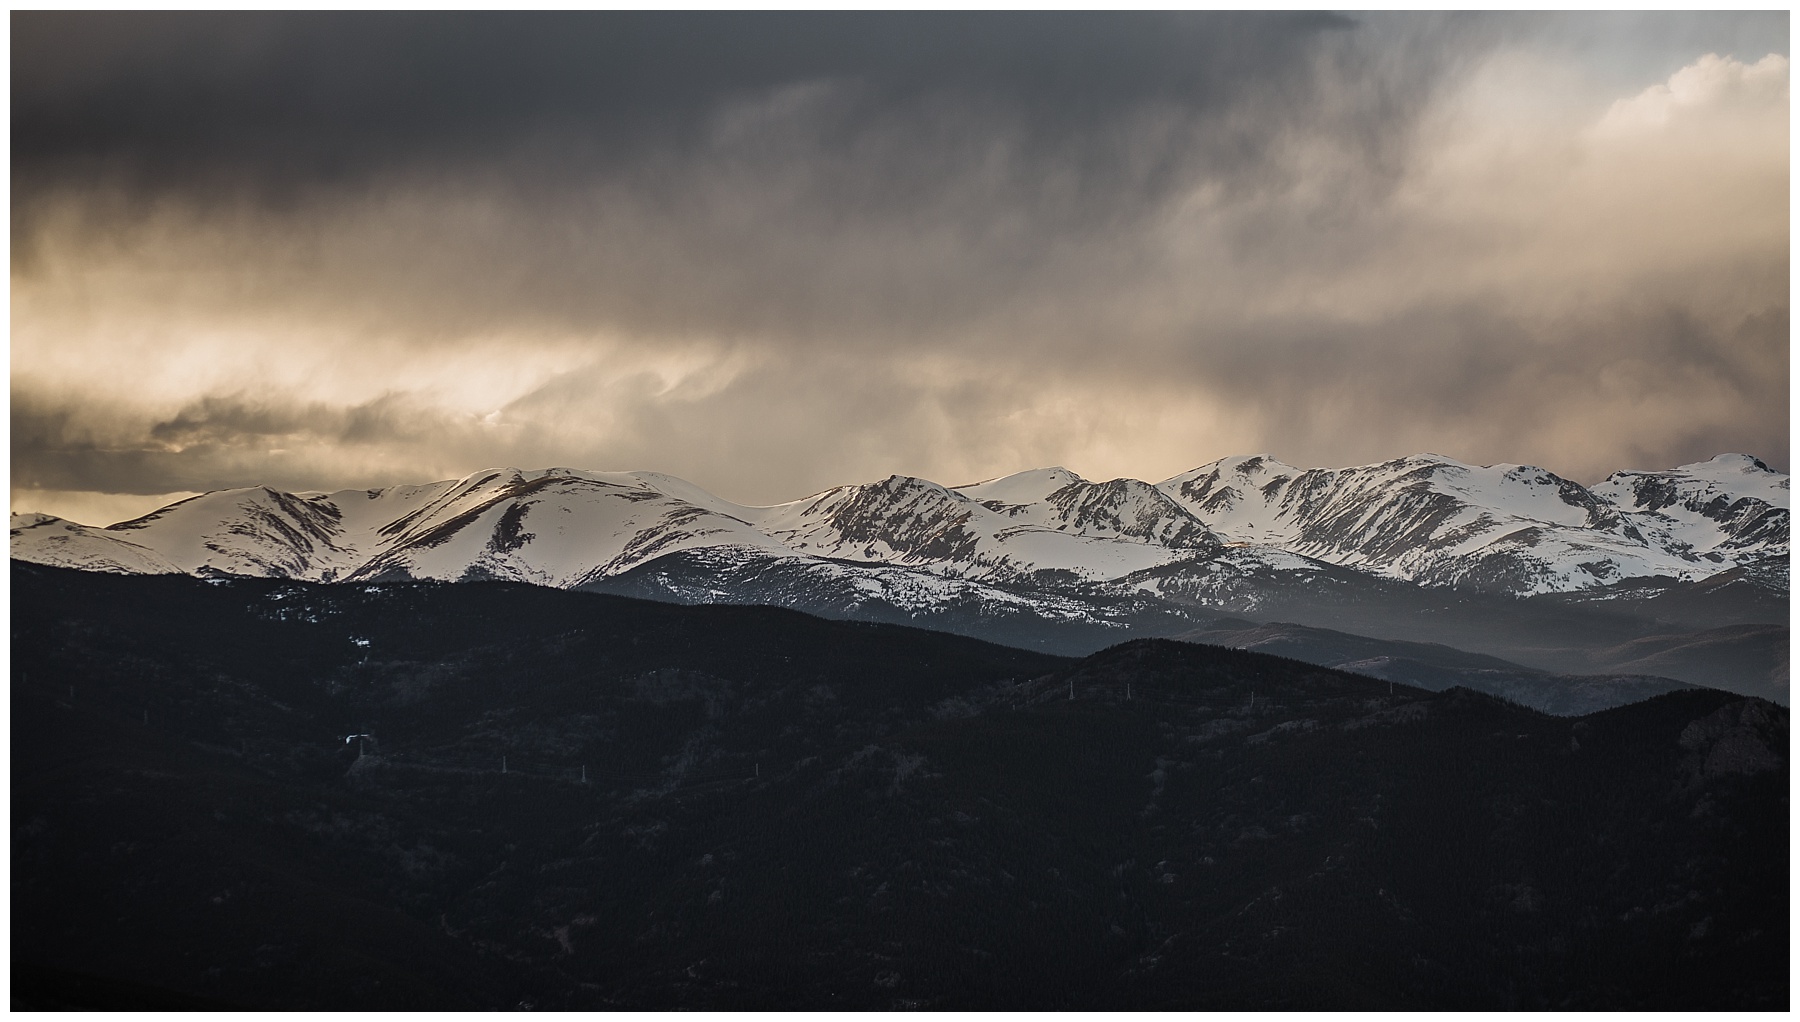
13,21,1787,520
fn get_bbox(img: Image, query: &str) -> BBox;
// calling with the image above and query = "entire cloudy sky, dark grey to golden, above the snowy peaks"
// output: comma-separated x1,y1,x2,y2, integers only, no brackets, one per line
11,11,1789,524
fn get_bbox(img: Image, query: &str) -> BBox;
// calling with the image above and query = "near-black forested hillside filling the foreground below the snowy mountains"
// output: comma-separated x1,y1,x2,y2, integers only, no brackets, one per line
13,565,1787,1008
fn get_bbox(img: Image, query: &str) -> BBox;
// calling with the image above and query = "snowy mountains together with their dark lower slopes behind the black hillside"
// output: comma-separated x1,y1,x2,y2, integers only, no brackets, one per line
13,455,1789,709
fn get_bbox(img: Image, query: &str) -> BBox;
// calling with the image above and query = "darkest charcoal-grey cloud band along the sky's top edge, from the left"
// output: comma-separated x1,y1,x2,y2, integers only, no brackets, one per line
13,13,1352,184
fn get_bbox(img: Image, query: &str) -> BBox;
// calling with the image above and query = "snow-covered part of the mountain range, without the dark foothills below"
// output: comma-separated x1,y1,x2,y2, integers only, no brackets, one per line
13,453,1789,610
